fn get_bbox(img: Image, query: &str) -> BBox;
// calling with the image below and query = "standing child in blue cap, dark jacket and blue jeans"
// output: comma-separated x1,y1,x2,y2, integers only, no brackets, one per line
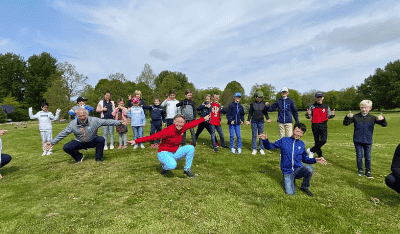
226,93,244,154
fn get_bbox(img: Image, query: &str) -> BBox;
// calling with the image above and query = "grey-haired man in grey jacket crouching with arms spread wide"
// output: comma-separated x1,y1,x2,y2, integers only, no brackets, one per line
45,108,127,163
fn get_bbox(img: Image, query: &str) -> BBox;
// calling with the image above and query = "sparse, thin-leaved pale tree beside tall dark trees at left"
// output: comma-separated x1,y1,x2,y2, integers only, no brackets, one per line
57,62,88,101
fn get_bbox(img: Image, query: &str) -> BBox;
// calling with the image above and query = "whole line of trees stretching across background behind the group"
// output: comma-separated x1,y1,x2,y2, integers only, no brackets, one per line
0,52,400,122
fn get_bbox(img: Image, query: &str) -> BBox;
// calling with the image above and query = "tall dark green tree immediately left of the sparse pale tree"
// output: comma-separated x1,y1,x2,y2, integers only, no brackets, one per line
25,52,57,109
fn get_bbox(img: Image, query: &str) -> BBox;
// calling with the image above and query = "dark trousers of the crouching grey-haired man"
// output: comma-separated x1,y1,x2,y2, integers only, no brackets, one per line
63,136,105,162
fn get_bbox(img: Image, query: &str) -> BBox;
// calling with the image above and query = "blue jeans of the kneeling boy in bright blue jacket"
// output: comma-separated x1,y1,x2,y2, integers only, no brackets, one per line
283,164,314,195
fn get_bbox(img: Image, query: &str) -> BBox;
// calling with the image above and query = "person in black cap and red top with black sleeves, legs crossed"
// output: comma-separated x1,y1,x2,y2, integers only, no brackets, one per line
306,92,335,157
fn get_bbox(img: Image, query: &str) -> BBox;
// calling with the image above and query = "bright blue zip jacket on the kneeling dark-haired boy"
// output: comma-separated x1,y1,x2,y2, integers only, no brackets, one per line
262,137,317,174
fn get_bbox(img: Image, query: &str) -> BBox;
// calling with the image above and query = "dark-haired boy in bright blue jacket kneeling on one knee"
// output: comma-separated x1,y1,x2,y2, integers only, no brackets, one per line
258,123,326,197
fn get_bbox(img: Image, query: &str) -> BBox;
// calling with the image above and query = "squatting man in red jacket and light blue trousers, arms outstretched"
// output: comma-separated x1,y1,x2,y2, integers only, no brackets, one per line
128,115,210,178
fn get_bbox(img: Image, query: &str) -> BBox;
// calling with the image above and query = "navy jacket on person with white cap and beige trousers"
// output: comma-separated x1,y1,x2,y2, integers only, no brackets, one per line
268,98,299,124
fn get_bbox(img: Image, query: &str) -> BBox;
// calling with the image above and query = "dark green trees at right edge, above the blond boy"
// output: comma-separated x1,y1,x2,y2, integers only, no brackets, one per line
358,60,400,109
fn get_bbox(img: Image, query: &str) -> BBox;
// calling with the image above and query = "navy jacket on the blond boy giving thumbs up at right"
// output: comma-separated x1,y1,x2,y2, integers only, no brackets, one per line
343,113,387,144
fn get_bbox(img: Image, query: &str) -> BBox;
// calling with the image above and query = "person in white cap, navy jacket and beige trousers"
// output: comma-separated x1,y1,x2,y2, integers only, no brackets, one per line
266,87,299,138
